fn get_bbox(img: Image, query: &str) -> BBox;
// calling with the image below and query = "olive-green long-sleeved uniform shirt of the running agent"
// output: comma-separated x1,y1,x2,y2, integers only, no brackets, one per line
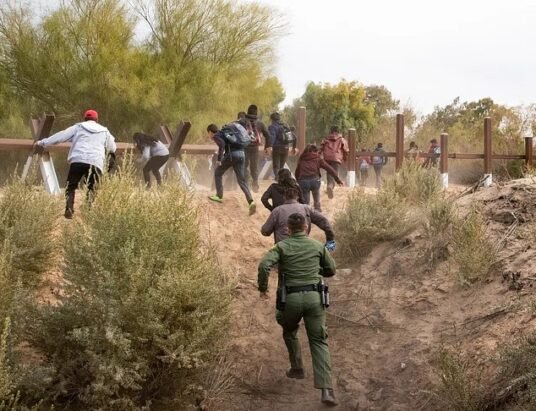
258,231,336,292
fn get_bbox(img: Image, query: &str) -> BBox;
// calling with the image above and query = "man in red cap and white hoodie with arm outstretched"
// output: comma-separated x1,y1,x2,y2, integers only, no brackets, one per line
36,110,116,218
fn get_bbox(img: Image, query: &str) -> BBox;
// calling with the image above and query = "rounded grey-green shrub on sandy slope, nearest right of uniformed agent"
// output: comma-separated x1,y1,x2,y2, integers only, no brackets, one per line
335,190,414,257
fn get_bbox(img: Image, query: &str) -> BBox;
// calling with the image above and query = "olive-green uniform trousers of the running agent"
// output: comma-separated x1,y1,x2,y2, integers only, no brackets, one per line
276,291,333,389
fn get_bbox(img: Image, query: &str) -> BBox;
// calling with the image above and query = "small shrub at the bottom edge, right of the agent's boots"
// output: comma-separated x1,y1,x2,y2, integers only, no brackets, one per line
435,349,482,411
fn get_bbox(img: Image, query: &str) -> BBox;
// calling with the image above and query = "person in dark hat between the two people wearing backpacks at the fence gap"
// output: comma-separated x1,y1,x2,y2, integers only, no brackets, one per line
244,104,271,193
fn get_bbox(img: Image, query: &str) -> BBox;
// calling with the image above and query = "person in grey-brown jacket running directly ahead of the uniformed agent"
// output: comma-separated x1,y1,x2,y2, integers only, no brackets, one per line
261,188,335,246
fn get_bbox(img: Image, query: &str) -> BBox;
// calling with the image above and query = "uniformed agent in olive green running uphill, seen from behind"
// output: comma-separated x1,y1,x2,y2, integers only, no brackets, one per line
258,213,337,405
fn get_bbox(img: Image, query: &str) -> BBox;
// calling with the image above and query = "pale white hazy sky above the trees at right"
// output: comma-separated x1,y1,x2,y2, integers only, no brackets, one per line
260,0,536,114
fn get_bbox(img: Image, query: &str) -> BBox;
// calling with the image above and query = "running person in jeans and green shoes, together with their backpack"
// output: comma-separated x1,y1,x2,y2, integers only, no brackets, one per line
207,120,257,215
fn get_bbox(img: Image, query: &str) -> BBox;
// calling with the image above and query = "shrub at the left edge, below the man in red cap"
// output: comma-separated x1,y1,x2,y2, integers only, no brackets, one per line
0,178,60,288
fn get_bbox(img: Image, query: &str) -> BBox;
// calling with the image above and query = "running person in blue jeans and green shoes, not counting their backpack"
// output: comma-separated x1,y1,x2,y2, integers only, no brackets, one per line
207,124,257,215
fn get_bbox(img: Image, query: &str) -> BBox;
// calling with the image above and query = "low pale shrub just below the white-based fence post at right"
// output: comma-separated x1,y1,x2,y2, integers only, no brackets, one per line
382,161,443,205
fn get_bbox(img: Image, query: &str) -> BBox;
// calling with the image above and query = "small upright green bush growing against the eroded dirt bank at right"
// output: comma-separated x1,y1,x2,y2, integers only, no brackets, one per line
452,210,495,286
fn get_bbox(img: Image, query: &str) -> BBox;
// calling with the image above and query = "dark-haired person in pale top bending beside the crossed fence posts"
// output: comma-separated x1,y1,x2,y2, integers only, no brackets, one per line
132,133,169,188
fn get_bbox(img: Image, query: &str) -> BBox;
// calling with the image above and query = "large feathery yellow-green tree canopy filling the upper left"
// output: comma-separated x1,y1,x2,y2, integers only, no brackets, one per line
0,0,284,139
